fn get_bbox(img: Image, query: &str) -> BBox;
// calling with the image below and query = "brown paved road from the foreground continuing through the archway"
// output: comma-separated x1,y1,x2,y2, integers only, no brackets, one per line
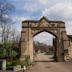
26,53,72,72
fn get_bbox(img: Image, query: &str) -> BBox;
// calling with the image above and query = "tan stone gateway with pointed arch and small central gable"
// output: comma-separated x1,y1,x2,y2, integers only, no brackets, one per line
21,17,70,61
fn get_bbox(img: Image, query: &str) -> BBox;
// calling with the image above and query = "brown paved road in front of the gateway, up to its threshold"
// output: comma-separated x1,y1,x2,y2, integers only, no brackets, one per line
26,62,72,72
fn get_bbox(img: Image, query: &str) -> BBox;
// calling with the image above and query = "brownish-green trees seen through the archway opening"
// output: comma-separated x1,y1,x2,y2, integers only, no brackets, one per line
34,42,54,54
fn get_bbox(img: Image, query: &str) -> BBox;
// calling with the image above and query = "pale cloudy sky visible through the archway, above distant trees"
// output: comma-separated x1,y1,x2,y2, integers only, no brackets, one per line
33,32,54,45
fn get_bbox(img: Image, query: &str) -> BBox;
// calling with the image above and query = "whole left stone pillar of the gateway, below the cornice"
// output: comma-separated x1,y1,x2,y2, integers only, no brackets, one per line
20,28,33,61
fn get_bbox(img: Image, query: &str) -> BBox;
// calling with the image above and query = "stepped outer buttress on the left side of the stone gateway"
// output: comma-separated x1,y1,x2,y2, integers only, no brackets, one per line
20,28,29,60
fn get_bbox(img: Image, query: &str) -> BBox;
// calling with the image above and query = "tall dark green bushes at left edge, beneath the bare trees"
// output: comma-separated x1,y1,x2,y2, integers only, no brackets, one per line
0,42,17,58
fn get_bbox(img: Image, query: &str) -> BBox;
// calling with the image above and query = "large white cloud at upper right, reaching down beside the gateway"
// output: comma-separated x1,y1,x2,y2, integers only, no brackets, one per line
42,3,72,34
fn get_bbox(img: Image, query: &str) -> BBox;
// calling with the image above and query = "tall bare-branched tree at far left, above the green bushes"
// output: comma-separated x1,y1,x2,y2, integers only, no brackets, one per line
0,0,14,42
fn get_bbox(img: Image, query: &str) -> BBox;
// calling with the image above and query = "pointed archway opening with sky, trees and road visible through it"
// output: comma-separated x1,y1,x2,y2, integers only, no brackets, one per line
33,30,57,62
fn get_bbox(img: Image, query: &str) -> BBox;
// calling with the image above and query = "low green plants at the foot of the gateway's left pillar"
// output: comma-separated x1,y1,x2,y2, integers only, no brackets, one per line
7,55,32,69
